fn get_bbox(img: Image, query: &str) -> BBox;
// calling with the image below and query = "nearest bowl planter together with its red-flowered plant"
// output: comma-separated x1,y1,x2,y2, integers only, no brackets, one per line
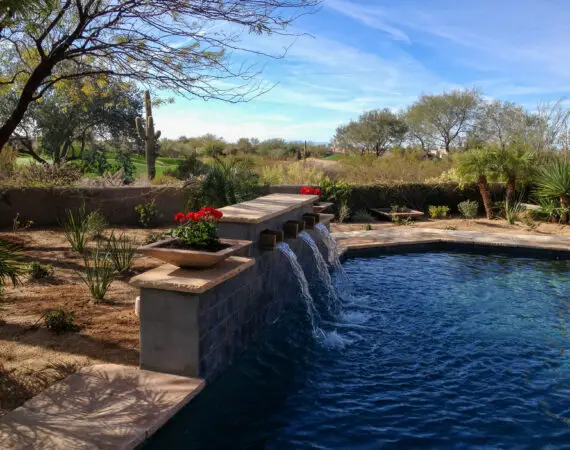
139,206,251,269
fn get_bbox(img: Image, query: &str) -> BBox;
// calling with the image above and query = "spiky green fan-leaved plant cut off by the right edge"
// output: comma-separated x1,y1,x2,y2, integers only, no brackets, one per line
536,159,570,223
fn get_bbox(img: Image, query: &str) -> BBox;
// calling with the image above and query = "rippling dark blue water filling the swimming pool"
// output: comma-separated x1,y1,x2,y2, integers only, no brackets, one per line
147,252,570,449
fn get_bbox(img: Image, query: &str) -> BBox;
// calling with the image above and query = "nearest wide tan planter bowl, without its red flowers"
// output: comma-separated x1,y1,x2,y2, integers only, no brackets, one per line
137,238,251,269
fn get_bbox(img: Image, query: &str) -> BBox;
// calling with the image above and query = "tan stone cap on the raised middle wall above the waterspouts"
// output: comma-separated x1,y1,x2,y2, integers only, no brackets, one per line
220,194,319,223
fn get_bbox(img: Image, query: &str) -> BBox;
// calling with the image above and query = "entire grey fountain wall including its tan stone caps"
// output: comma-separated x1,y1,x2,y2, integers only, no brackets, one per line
132,195,330,379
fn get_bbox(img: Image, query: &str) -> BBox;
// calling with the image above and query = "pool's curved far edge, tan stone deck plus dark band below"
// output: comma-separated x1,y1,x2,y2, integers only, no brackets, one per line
332,227,570,258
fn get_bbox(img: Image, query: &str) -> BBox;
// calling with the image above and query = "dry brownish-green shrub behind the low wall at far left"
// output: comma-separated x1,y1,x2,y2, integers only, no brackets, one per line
13,163,81,186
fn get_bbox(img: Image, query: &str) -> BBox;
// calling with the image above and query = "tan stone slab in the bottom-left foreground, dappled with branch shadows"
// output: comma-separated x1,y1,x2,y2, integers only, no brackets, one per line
0,364,205,450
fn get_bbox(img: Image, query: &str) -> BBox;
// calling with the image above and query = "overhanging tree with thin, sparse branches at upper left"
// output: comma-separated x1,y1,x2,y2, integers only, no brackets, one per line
0,0,318,151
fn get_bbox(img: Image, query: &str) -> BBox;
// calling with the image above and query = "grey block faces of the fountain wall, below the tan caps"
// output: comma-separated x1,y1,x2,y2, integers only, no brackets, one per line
136,196,325,379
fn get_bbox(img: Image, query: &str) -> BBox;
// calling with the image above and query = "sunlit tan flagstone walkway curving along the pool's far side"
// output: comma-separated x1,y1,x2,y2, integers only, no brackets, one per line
333,226,570,252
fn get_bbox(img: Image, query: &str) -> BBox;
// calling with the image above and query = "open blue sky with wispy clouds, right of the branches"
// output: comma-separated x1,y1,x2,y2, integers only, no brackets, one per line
155,0,570,142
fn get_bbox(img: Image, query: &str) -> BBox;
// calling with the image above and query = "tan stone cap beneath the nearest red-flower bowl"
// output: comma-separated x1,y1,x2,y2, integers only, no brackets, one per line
130,256,255,294
